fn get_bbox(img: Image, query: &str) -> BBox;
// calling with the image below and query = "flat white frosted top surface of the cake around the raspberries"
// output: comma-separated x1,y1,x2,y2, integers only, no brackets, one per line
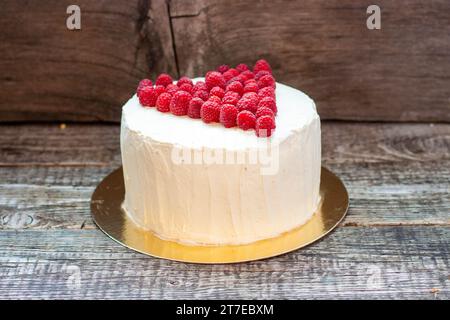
122,78,319,150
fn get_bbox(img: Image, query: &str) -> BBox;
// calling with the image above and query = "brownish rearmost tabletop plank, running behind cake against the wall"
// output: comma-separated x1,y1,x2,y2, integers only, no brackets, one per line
0,121,450,166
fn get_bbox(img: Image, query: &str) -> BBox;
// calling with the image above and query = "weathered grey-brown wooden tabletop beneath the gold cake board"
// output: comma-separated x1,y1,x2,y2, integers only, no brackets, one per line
0,122,450,299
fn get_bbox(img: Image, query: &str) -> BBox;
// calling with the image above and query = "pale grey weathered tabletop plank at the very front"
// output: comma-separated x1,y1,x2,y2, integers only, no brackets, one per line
0,227,450,299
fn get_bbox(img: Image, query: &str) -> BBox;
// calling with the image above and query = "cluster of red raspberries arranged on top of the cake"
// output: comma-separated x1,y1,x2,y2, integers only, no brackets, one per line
136,59,277,137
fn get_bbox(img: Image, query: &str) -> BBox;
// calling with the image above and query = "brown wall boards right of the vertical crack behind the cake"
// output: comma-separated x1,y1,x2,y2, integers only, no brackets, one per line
170,0,450,122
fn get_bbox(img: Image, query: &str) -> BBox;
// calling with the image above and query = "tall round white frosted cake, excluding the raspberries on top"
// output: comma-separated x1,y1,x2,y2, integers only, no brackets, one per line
121,78,321,245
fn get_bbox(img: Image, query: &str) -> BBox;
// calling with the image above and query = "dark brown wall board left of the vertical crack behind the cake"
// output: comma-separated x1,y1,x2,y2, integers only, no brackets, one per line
0,0,176,121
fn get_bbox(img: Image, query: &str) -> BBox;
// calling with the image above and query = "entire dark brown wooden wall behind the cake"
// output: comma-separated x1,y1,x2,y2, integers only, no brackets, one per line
0,0,450,122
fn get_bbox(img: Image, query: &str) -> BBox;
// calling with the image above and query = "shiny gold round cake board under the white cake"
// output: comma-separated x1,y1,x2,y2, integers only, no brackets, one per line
91,167,349,263
